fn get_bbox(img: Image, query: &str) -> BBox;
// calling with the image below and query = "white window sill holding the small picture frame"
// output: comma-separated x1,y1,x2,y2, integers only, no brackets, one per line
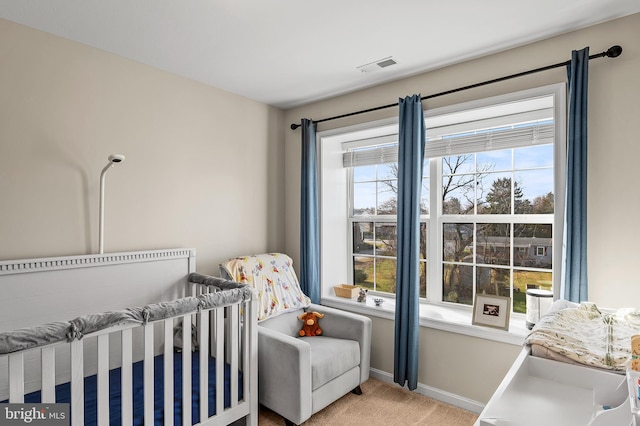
321,295,529,346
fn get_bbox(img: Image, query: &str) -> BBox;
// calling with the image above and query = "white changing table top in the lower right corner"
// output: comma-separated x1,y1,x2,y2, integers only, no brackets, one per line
475,348,640,426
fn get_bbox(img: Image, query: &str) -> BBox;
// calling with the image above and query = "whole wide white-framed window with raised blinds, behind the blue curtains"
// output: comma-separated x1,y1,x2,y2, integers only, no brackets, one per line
320,85,565,320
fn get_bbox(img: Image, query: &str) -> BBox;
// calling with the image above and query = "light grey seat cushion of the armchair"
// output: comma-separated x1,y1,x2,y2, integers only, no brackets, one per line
300,336,360,390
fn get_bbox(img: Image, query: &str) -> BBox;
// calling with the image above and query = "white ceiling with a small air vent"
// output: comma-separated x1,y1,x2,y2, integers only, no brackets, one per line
0,0,640,109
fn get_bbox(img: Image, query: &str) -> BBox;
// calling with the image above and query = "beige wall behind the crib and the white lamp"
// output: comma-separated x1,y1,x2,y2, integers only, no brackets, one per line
0,20,285,274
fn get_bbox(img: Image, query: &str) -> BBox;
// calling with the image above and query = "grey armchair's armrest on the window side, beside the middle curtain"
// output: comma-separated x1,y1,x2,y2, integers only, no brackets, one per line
307,303,371,383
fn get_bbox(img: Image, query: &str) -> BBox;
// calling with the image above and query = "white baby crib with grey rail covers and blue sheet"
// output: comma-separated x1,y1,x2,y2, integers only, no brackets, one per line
0,249,258,426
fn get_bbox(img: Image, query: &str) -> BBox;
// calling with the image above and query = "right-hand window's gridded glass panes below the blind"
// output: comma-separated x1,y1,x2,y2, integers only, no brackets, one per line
439,146,554,312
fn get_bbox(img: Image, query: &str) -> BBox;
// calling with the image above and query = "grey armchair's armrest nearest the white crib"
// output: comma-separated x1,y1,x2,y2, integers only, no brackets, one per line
258,326,312,424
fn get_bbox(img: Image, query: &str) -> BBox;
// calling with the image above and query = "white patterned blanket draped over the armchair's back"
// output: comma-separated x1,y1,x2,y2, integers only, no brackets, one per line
220,253,311,321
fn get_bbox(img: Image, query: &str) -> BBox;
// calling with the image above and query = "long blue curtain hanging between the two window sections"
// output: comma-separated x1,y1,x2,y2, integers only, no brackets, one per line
393,95,425,390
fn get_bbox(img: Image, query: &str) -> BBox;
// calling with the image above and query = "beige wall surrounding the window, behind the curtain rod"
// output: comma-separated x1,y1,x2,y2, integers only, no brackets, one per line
285,14,640,402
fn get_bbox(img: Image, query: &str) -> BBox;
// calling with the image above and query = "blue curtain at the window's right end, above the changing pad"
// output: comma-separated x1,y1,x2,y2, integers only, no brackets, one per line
563,47,589,302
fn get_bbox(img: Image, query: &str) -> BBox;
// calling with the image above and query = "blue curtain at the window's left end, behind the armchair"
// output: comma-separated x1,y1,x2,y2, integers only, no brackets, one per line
300,118,320,303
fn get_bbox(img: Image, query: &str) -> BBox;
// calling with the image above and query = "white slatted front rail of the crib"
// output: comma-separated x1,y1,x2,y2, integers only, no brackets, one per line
0,286,258,426
